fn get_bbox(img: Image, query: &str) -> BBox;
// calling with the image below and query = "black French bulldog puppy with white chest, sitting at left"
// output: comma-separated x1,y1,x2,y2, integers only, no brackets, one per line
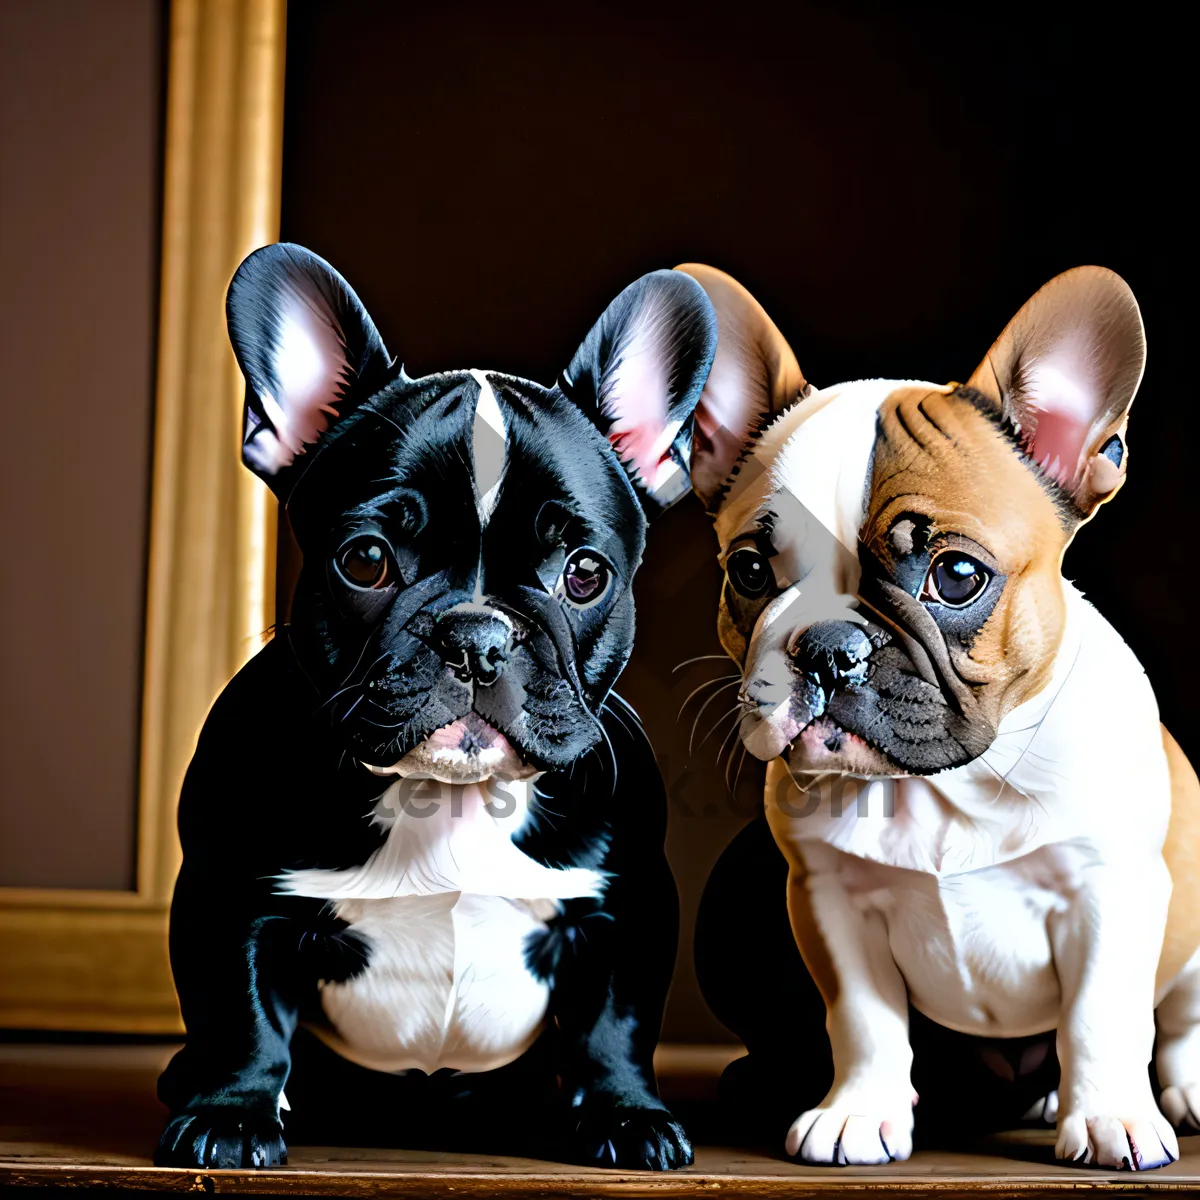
155,245,716,1170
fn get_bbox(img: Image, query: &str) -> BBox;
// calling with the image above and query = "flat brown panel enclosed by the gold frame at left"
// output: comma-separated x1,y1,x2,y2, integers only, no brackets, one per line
0,0,162,888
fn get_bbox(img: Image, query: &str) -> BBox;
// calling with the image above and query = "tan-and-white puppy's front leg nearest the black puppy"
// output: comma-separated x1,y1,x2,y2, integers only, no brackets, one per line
780,847,916,1164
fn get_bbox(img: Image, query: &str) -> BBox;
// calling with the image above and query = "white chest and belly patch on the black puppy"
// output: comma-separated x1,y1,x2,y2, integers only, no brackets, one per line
280,779,606,1072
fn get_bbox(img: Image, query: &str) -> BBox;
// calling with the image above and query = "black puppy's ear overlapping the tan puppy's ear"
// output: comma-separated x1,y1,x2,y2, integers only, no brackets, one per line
558,271,716,516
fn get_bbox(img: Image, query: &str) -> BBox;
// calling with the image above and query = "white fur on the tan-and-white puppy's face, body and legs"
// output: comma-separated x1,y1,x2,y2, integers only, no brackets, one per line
734,380,1185,1166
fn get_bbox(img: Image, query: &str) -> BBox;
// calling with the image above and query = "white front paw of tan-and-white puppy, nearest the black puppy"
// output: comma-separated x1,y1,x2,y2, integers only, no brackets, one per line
784,1090,916,1166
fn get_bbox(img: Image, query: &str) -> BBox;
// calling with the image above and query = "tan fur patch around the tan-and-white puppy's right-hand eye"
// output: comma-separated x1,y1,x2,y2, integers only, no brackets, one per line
863,388,1068,725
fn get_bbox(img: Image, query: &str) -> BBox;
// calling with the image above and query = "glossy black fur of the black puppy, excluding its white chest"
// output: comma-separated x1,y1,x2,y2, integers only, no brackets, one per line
156,246,715,1169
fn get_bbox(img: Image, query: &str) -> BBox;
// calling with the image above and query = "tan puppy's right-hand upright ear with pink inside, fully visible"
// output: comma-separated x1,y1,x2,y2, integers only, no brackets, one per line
970,266,1146,518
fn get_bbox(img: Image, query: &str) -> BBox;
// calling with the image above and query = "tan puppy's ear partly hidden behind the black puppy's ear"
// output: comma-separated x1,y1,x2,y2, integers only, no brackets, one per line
676,263,809,512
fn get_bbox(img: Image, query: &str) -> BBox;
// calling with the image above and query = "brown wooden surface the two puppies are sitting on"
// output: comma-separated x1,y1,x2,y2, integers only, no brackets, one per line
0,1043,1200,1200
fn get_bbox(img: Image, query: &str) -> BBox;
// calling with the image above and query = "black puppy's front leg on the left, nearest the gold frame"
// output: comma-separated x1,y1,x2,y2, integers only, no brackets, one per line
155,864,296,1168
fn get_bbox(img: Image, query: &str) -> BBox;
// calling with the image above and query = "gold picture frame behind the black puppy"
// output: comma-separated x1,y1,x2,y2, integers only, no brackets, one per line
0,0,287,1033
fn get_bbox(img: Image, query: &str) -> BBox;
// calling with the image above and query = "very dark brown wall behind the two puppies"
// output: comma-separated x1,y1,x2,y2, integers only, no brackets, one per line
283,0,1200,1038
